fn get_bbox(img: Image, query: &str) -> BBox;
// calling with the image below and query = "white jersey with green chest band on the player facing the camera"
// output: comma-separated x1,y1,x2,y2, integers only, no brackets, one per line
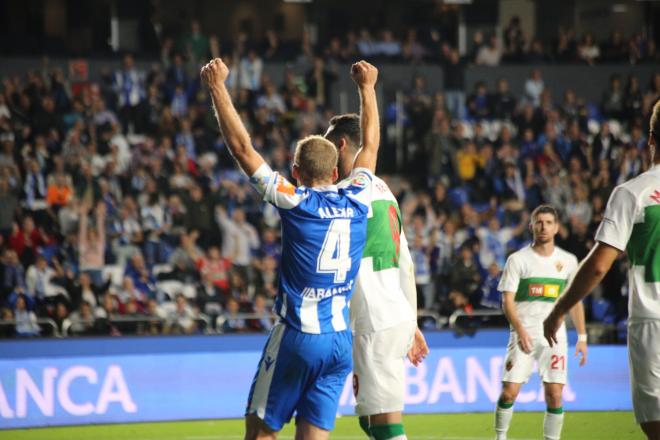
497,245,578,334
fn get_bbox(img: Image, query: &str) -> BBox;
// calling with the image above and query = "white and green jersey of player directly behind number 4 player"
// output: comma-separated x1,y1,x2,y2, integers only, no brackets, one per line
340,176,417,335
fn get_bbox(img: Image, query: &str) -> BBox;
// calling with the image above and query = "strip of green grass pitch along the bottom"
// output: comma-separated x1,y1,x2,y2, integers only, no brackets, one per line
0,412,644,440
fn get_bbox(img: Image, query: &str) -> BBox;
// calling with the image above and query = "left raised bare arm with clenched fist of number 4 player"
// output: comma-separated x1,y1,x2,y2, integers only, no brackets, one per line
200,58,265,176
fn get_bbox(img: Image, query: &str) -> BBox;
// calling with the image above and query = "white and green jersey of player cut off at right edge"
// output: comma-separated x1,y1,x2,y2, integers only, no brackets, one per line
596,165,660,322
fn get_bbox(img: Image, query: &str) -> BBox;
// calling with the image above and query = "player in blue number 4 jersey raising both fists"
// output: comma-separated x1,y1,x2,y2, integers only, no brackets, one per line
201,58,380,440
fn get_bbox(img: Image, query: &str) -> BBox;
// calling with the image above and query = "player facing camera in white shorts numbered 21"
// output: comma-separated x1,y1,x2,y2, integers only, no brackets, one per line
495,205,587,440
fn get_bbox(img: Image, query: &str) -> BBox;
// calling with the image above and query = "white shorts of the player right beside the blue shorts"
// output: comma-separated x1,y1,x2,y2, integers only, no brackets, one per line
353,321,417,416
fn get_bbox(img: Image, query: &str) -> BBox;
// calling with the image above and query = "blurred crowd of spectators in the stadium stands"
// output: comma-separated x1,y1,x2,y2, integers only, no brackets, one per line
0,20,660,336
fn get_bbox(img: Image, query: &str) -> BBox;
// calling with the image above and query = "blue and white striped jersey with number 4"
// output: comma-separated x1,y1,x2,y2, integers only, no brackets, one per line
250,164,373,333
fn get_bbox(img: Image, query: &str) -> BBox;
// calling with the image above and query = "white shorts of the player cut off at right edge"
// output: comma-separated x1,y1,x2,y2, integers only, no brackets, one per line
628,321,660,423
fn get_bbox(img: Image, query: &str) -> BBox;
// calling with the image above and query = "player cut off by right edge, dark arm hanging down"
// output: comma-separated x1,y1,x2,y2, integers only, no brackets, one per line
543,101,660,440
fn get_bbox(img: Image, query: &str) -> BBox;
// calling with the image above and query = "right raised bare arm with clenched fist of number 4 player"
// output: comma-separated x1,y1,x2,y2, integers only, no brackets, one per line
351,61,380,173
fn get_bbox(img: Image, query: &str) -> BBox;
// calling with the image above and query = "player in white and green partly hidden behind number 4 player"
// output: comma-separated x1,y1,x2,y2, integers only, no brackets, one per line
325,114,428,440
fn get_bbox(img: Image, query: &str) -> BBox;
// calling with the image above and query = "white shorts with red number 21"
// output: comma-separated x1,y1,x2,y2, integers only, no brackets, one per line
502,332,568,384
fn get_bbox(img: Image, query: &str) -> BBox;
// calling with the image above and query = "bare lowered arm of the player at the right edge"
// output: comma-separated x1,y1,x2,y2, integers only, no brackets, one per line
543,241,621,346
